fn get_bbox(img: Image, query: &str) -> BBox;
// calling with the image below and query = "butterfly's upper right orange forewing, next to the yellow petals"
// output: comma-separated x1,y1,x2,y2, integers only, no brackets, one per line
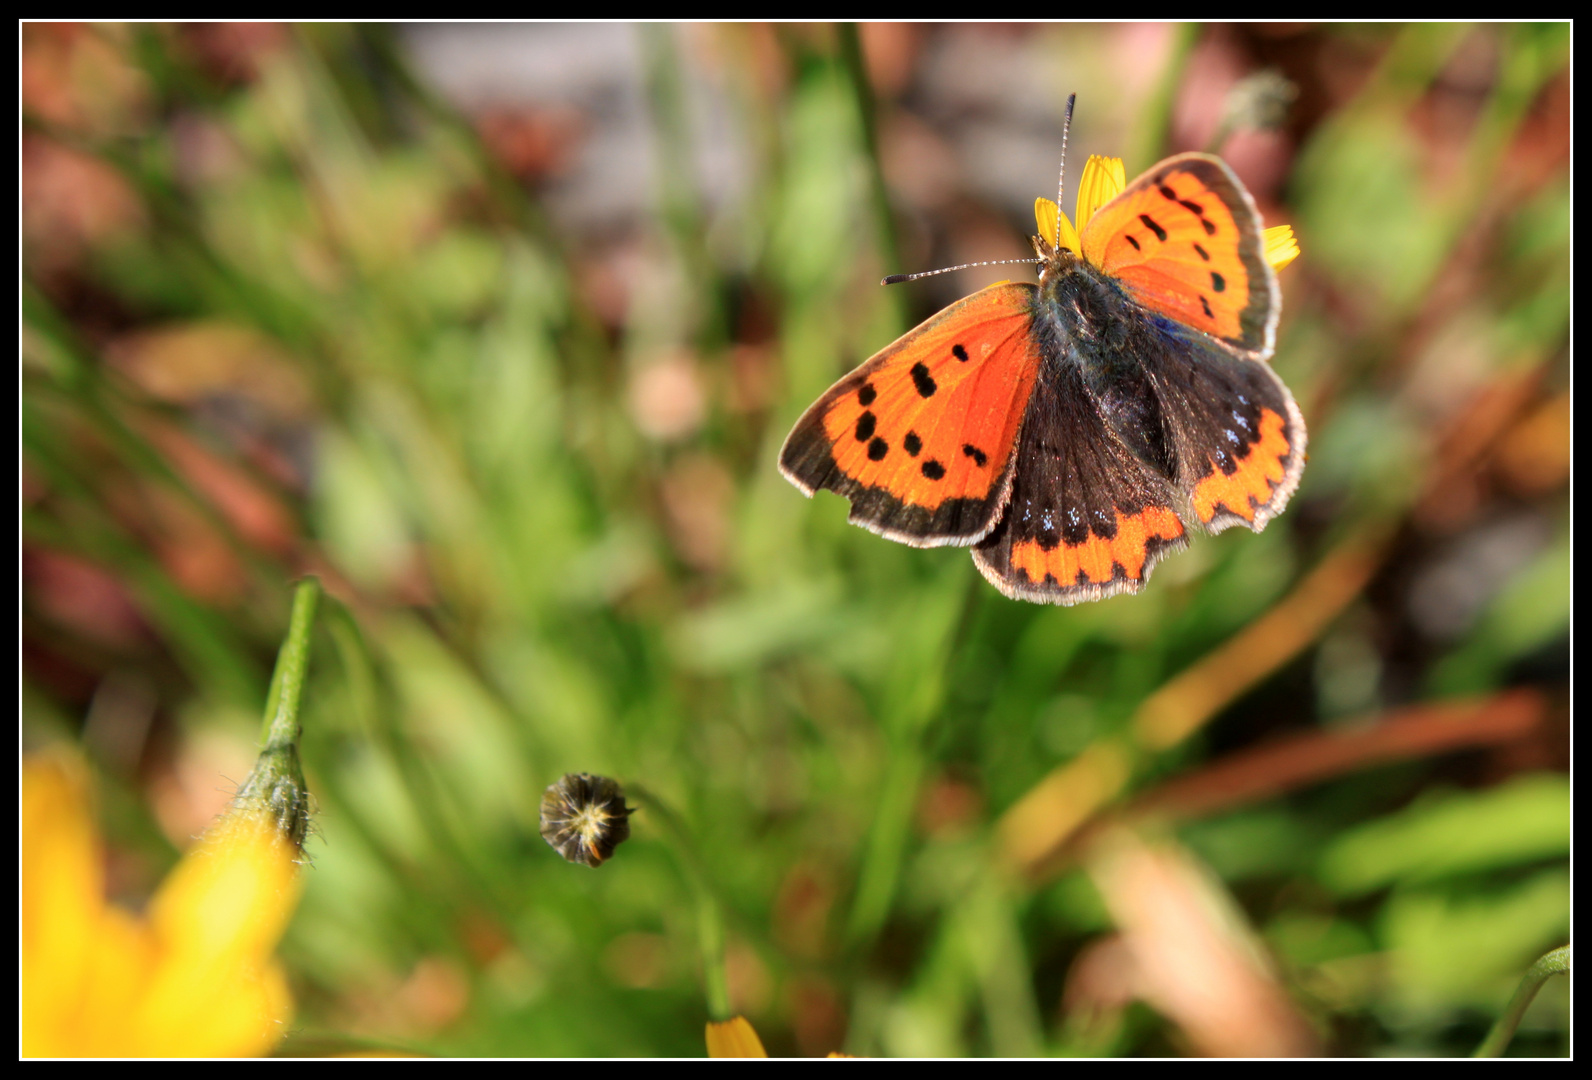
1079,153,1280,360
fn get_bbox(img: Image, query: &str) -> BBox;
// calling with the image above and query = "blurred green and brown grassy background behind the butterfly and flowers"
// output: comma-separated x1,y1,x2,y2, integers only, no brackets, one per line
21,24,1570,1056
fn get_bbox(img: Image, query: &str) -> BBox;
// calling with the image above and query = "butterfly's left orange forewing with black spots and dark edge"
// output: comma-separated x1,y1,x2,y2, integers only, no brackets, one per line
780,282,1040,548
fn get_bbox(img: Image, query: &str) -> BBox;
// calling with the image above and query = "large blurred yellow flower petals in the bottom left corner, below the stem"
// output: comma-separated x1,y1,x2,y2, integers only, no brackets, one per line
21,757,299,1058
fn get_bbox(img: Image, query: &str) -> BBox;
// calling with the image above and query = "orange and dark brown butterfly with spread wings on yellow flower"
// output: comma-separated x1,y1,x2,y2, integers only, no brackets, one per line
780,100,1305,604
